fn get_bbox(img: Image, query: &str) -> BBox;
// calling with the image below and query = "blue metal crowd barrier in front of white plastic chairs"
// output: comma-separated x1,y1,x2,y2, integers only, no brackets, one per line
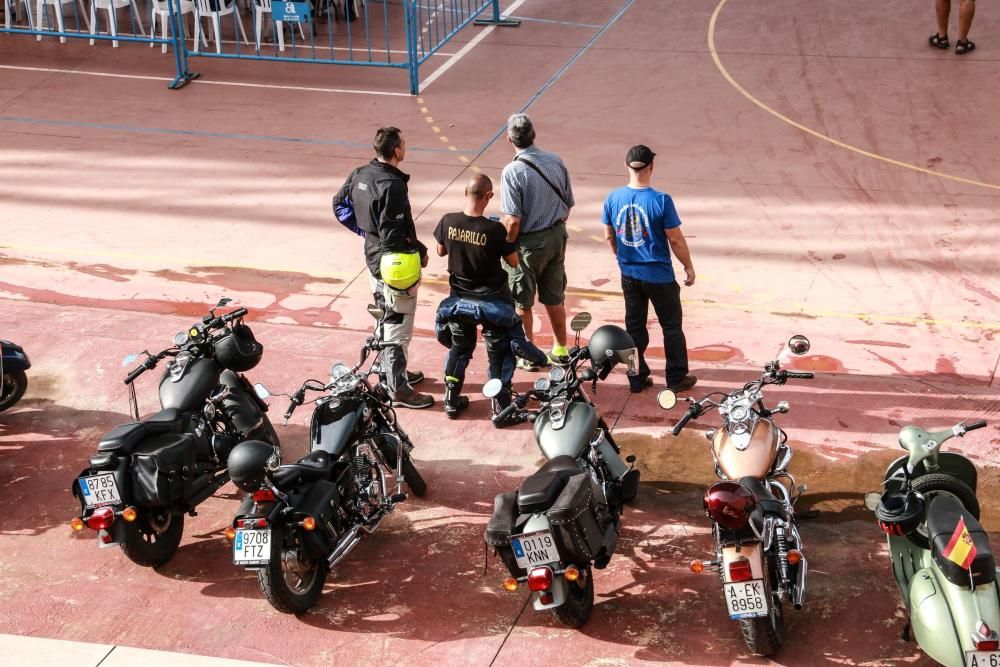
0,0,517,94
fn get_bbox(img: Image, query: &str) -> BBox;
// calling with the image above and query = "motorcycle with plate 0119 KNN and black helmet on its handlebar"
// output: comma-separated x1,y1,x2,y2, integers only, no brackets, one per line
483,313,639,628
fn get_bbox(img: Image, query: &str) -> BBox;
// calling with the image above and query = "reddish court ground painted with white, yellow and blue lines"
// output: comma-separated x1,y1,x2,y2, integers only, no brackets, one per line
0,0,1000,666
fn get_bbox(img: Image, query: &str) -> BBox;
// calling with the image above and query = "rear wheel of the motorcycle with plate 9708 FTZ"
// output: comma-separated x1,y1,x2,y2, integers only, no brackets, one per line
257,523,326,614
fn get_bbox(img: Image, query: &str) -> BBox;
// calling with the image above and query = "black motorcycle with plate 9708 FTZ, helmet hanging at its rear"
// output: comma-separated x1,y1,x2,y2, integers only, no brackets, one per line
226,306,427,614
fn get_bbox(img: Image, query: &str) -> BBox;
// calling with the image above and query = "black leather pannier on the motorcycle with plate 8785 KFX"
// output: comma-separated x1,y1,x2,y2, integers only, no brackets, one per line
132,433,196,507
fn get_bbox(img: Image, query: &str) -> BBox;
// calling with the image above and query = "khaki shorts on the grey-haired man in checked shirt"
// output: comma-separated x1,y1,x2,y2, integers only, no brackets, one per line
504,222,569,310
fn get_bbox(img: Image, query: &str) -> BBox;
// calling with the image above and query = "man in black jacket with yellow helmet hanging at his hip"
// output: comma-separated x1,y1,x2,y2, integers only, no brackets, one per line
333,127,434,408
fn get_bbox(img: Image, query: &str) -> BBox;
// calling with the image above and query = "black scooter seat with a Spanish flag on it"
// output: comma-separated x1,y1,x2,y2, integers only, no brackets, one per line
927,495,996,588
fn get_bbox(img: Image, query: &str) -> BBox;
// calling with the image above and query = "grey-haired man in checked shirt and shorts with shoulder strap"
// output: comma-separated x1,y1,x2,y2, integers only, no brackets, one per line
500,114,574,371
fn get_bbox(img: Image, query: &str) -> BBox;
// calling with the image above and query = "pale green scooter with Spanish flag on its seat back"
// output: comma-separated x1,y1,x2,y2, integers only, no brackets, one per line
865,420,1000,667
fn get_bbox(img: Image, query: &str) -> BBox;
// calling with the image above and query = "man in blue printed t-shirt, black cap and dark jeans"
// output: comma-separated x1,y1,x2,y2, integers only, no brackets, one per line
604,145,698,392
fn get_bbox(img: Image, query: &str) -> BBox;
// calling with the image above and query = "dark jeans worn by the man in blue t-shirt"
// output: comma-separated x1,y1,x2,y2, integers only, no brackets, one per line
622,276,688,387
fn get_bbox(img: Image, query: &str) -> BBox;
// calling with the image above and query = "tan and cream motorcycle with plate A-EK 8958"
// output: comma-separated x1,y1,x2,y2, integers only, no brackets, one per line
658,336,813,656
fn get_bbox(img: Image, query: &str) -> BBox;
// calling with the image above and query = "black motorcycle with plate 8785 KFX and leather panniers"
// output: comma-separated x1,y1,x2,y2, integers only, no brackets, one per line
71,299,279,567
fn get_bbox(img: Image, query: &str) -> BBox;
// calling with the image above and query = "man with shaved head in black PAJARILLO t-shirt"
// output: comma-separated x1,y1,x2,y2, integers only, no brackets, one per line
434,174,520,419
